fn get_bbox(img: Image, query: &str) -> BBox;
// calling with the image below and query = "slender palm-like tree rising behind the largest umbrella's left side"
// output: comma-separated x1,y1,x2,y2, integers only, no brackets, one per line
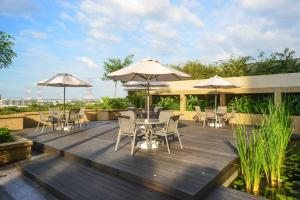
102,55,134,97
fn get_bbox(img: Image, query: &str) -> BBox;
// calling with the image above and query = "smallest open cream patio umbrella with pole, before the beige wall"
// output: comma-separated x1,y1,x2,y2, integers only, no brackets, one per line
194,75,239,126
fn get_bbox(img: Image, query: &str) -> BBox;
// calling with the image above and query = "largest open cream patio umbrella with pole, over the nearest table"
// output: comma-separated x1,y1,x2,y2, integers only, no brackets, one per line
108,59,190,119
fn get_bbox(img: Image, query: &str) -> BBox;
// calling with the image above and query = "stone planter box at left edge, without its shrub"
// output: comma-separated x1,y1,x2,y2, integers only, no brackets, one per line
0,136,32,165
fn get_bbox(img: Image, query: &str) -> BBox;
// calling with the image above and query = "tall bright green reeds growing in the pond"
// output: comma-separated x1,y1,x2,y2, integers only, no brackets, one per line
236,100,293,195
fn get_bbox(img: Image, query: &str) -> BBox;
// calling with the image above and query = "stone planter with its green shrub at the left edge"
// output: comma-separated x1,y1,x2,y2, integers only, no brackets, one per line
0,128,32,165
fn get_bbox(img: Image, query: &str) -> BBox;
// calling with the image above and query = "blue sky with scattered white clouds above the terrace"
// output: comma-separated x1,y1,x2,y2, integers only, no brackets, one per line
0,0,300,99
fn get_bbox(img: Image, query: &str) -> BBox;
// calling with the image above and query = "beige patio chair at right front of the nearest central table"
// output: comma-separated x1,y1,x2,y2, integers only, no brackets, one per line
152,115,183,154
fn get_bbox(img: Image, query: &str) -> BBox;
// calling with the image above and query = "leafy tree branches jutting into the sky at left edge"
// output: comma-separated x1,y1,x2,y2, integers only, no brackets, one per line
0,31,17,69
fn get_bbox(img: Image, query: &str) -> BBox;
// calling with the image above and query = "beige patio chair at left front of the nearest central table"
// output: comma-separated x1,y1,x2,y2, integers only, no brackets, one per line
115,115,145,155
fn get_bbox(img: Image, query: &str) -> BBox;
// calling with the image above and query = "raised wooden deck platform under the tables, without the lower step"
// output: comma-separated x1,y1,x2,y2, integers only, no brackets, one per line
18,121,246,199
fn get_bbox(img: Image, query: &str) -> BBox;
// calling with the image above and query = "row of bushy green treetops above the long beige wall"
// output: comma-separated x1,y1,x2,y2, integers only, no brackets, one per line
174,48,300,79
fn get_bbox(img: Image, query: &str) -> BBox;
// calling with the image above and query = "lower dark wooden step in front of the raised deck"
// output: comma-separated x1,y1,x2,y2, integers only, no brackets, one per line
20,154,174,200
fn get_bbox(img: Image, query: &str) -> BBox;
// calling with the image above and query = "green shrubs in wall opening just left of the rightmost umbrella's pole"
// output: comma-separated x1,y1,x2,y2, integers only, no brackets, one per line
186,95,215,111
